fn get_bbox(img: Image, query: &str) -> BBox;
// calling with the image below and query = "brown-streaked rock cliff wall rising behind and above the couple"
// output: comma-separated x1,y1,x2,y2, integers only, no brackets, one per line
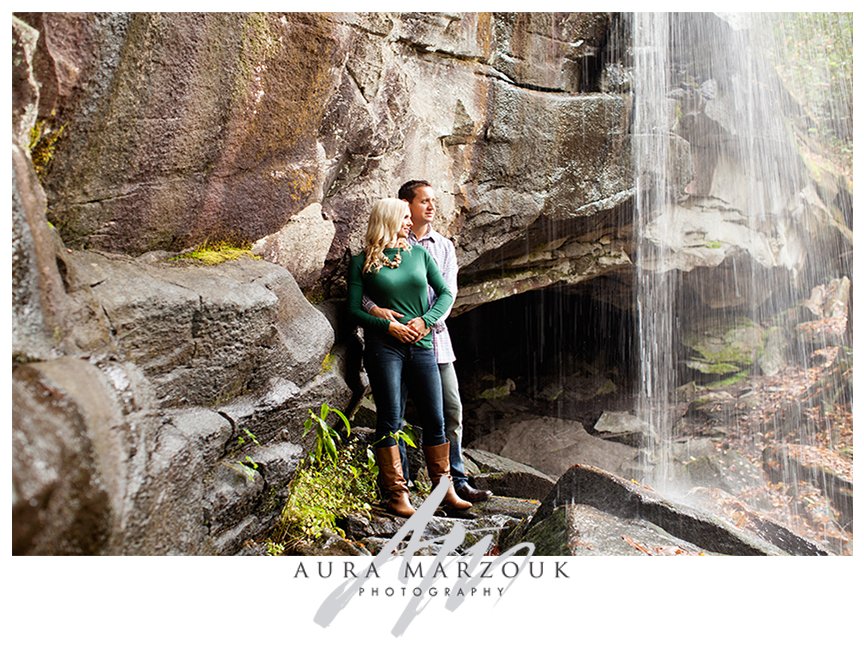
22,14,631,298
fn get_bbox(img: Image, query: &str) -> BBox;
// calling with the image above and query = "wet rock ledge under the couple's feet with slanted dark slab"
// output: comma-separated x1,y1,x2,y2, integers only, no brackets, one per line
258,450,828,556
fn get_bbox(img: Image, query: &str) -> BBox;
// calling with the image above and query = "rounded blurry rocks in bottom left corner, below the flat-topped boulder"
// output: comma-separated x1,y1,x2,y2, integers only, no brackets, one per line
12,356,332,555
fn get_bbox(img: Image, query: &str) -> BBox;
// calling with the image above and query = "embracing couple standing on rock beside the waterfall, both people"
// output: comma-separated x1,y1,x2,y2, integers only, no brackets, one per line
348,180,492,517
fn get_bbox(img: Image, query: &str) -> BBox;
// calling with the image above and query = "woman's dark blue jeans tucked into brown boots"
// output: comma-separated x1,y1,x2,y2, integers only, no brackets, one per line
363,332,447,448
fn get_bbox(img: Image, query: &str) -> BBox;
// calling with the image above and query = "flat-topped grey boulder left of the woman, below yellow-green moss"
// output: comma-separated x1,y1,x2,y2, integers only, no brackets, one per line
70,252,334,407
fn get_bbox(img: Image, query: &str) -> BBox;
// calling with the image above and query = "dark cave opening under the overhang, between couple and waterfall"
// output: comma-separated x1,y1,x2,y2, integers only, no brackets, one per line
448,276,639,444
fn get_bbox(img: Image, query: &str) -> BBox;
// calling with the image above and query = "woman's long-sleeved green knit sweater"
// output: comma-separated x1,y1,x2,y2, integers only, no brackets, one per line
348,246,453,349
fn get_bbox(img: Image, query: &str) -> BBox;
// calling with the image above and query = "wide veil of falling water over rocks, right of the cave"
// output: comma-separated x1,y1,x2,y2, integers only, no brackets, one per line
631,13,852,552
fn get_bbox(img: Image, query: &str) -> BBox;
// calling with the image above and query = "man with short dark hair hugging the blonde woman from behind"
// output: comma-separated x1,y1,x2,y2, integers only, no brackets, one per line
363,180,492,503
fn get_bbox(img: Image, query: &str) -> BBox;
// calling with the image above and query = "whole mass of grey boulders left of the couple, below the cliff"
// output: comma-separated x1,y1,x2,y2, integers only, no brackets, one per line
12,192,351,554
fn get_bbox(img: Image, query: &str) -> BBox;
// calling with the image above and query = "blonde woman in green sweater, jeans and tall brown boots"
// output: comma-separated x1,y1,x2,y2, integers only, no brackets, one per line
348,199,471,517
